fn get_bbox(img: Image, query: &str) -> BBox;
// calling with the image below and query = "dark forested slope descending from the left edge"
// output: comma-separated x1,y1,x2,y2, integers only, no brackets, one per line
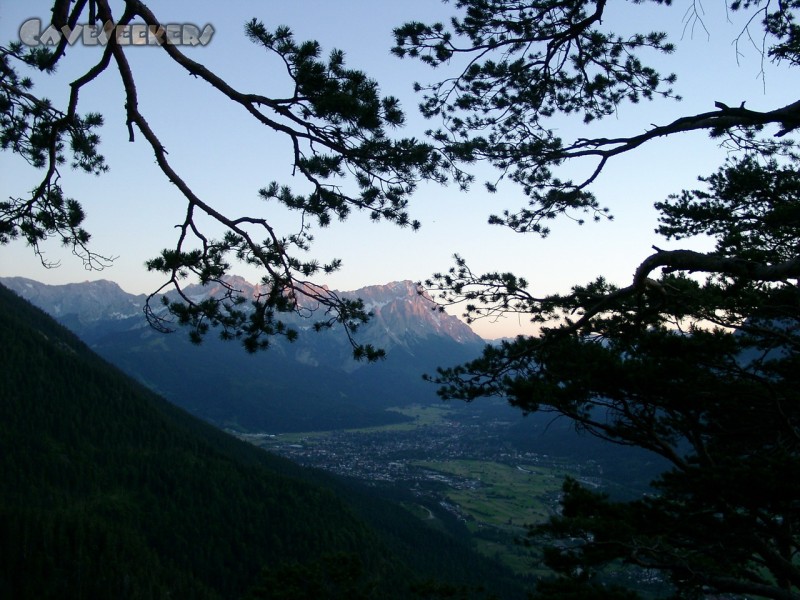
0,287,524,598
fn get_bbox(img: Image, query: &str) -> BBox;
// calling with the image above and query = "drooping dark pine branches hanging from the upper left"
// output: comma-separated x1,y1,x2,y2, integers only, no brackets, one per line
0,0,445,360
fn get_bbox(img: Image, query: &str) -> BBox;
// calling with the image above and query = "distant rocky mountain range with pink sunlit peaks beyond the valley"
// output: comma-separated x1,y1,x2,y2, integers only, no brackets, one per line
0,277,485,433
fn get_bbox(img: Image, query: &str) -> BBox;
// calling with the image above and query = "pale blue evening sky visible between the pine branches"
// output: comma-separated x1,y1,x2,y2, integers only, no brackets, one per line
0,0,798,338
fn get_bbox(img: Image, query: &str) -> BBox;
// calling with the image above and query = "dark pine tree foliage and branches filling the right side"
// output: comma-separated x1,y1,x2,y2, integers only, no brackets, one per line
394,0,800,599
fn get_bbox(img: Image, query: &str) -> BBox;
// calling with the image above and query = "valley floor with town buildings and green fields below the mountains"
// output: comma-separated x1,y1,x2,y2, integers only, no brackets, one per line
231,405,603,577
